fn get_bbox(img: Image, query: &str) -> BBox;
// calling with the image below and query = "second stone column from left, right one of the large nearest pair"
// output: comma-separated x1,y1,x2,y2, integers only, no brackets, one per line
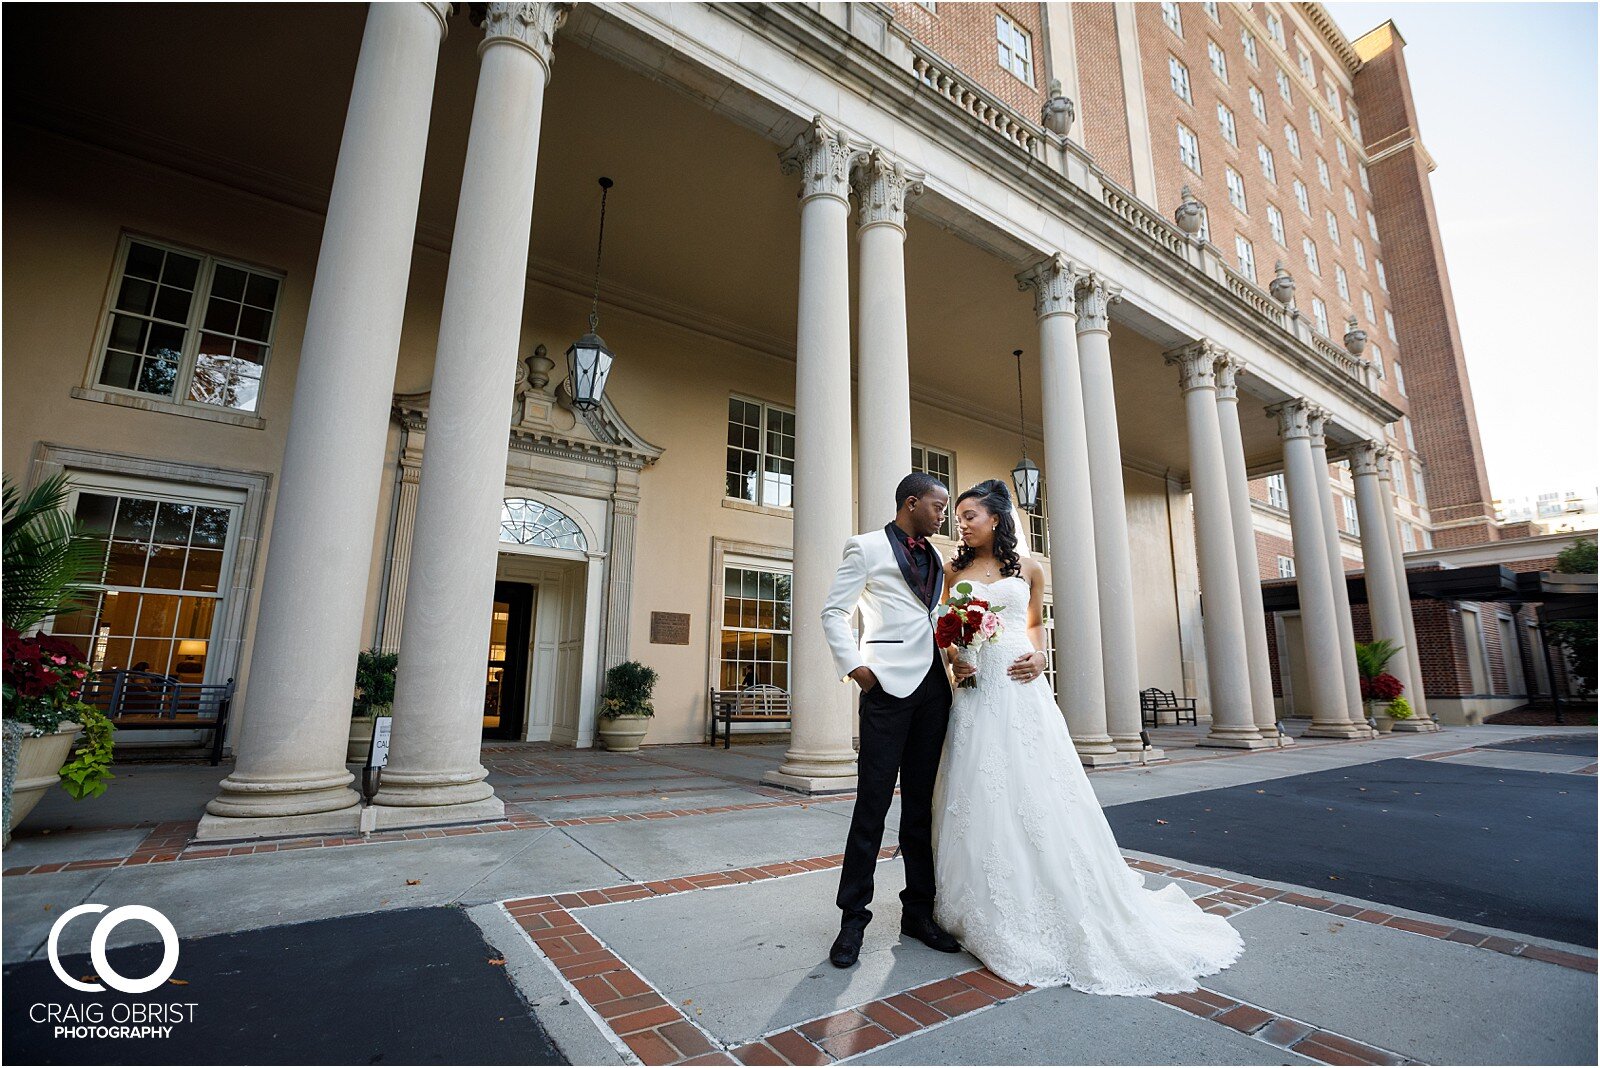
373,3,570,827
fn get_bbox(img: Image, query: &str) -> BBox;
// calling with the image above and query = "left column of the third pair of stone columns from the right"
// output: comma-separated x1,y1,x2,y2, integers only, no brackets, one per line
1166,339,1277,750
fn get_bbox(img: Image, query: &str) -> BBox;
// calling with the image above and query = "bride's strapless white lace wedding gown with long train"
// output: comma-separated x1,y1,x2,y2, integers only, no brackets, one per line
933,577,1245,996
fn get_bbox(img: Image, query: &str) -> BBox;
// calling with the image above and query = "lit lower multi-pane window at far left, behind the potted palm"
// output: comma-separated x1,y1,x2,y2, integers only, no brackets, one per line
51,489,237,683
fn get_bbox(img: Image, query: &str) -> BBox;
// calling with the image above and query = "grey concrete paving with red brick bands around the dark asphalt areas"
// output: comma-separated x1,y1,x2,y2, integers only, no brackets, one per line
3,727,1597,1063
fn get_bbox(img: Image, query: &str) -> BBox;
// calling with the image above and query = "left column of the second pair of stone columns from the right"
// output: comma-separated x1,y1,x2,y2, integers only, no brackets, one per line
1272,400,1366,739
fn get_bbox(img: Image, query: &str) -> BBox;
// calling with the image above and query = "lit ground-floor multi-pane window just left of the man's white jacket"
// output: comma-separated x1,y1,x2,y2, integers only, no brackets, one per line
717,563,794,691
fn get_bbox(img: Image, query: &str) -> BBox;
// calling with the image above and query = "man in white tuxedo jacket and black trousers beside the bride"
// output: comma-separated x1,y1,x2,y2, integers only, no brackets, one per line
822,473,960,967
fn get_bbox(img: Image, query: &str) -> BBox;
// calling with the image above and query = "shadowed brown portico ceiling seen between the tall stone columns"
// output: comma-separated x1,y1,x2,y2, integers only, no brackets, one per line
5,5,1277,472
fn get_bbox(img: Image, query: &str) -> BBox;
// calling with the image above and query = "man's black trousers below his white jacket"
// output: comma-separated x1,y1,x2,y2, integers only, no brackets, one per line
838,649,950,929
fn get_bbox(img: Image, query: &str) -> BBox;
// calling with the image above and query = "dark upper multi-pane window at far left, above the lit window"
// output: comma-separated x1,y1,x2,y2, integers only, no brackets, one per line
94,238,282,412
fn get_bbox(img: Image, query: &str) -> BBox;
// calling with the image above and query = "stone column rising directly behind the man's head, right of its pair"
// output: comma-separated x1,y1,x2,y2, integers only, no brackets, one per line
851,149,921,531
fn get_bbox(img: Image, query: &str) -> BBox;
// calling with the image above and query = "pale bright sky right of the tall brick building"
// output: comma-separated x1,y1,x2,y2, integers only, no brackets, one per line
1325,3,1600,497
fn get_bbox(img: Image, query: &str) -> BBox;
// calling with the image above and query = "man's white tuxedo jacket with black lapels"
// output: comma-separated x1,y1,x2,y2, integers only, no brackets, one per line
822,529,944,697
